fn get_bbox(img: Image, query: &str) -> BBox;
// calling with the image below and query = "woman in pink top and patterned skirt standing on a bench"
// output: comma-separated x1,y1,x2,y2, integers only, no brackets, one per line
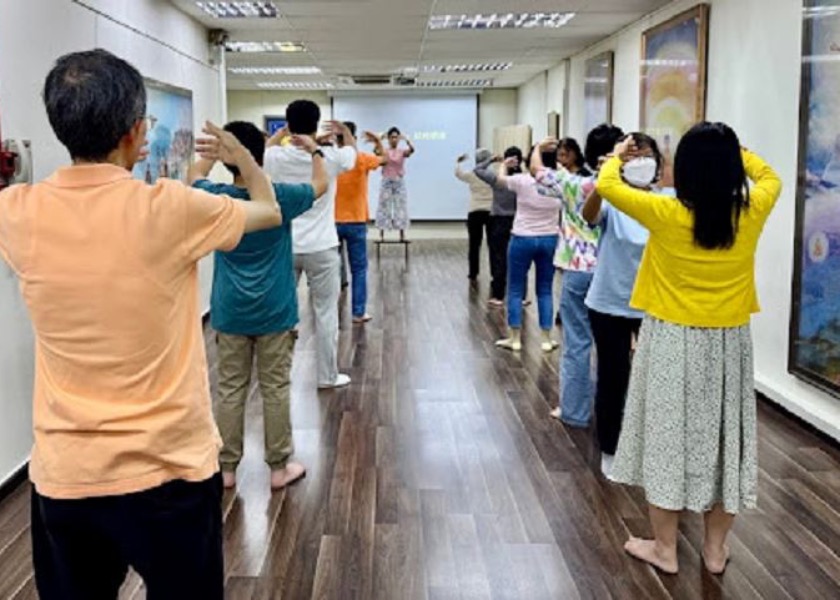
376,127,414,241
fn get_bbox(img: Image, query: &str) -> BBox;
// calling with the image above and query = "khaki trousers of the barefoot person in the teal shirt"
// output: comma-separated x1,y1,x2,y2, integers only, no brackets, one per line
214,331,297,472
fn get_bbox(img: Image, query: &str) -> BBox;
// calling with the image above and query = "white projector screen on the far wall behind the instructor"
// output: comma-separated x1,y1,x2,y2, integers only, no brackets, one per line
333,93,478,221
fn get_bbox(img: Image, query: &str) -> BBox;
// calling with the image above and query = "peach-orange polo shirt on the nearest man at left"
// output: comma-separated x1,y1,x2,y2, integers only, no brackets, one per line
0,165,246,499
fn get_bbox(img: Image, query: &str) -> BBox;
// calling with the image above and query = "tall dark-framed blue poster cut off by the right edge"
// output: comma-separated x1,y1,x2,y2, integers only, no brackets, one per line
788,0,840,395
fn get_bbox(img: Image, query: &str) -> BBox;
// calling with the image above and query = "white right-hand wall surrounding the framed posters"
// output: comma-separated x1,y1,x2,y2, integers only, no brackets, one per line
569,0,840,439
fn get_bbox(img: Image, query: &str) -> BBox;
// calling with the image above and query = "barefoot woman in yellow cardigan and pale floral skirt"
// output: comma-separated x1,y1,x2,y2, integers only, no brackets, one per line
597,123,782,574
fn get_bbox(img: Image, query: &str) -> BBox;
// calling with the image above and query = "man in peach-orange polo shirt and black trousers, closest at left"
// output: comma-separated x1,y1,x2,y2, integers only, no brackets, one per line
0,50,298,600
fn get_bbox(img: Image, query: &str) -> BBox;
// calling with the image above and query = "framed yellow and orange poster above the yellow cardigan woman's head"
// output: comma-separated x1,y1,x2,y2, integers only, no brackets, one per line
640,4,709,186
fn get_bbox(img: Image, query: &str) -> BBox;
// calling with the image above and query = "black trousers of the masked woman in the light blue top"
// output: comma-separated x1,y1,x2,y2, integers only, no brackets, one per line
589,310,642,454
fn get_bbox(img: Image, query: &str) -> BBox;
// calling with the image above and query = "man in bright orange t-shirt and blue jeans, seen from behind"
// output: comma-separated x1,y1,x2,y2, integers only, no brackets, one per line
335,121,384,323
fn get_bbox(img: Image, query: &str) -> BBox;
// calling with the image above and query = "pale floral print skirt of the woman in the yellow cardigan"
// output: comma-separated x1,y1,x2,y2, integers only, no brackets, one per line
611,317,758,514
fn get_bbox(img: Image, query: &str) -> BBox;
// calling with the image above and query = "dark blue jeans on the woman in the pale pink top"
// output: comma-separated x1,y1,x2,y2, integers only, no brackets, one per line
508,235,557,331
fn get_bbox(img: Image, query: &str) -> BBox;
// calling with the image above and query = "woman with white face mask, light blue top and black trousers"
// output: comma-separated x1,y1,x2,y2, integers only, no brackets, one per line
581,133,667,477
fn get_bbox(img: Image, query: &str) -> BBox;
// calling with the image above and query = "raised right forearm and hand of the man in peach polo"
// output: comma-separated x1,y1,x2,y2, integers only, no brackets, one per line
196,121,283,233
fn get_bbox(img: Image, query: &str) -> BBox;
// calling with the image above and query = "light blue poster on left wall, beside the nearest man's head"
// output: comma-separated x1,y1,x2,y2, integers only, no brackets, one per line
133,79,195,183
